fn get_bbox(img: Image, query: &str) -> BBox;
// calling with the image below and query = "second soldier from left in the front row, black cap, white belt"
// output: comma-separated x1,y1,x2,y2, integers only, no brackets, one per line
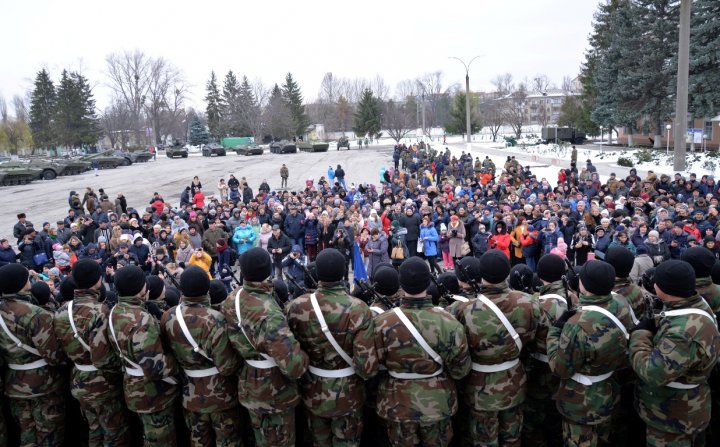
55,259,128,447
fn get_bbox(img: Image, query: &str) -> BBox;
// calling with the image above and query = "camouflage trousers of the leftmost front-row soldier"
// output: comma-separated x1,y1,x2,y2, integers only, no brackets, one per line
10,393,65,447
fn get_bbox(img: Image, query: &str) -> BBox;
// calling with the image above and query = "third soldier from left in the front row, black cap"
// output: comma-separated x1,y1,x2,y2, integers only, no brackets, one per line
108,265,180,447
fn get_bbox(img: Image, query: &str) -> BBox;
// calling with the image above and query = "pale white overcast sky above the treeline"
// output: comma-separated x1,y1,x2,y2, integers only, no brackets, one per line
0,0,599,108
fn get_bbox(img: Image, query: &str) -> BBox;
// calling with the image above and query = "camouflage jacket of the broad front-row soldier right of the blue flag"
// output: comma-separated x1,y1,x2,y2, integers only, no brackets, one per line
375,297,470,423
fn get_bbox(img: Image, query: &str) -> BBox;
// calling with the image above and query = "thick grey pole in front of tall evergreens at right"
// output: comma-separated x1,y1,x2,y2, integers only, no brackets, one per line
673,0,692,172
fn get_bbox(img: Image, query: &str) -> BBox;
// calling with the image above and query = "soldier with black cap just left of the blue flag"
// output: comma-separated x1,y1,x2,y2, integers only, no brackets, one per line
287,248,378,447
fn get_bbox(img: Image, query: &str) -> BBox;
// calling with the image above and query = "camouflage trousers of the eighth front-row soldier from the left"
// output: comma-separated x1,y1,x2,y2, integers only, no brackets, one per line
463,405,523,447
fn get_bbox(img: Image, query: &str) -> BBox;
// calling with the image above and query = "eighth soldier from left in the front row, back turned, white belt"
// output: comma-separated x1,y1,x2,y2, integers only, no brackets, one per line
451,250,540,446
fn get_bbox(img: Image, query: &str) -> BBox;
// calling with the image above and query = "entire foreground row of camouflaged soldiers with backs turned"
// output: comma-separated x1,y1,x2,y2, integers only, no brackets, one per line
0,243,720,446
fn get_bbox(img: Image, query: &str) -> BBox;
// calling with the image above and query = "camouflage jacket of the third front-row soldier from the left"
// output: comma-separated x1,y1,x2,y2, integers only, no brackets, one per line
108,296,180,413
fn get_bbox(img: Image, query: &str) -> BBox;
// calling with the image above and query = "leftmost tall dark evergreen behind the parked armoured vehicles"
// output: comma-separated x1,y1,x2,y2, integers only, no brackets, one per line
30,69,56,148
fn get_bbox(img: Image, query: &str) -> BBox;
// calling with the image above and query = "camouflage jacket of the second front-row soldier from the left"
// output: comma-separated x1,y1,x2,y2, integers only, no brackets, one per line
55,289,122,403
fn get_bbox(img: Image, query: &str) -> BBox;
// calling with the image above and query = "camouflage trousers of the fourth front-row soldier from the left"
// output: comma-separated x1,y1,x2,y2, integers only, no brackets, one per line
183,407,242,447
